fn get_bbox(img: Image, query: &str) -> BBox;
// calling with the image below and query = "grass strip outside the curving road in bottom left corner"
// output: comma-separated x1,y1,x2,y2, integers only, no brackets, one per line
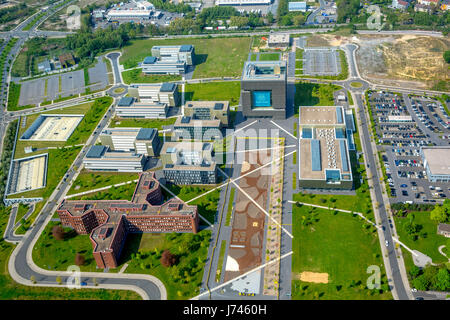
0,206,141,300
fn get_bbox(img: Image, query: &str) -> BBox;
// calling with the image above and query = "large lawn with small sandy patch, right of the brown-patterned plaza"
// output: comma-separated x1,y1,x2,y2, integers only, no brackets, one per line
292,206,392,300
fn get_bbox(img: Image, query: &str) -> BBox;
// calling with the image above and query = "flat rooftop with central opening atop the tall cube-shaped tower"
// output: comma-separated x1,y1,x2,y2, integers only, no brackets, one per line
242,60,286,81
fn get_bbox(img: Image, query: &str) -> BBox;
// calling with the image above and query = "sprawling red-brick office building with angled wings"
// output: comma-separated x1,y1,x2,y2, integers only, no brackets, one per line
57,173,198,268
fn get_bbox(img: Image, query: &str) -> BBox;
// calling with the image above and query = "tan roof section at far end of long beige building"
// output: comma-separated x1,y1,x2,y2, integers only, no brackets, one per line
299,106,345,126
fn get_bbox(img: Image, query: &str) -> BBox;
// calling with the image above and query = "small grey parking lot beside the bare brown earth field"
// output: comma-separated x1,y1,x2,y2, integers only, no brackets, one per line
303,48,341,76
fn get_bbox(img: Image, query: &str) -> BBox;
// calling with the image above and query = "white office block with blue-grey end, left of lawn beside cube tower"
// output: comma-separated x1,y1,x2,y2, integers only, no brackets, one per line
133,82,181,107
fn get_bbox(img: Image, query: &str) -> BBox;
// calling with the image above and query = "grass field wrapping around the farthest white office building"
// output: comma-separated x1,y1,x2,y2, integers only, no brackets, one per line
120,37,251,78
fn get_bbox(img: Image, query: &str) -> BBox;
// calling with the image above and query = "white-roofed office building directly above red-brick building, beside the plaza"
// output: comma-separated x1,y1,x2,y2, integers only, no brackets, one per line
161,142,217,184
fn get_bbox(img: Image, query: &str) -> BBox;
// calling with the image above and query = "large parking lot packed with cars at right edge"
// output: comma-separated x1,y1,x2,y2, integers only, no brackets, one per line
369,91,450,203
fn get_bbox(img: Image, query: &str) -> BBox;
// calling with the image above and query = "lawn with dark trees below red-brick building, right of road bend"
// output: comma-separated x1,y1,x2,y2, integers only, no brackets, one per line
119,230,211,300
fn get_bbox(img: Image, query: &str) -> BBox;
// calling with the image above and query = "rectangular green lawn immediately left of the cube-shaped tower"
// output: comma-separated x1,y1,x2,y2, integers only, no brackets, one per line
185,81,241,106
